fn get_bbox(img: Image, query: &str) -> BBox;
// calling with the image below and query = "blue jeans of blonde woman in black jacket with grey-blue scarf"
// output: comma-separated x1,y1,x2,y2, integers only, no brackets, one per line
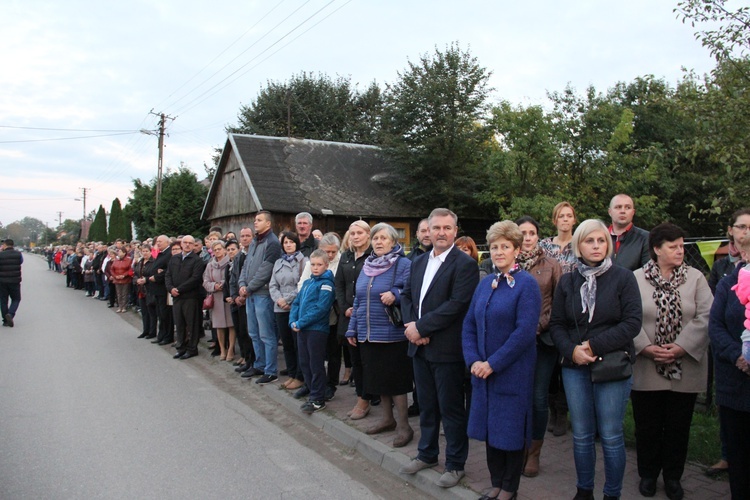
562,366,633,497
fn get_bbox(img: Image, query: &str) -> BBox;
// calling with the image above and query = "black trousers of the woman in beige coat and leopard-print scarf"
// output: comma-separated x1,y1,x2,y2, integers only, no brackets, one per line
630,391,698,481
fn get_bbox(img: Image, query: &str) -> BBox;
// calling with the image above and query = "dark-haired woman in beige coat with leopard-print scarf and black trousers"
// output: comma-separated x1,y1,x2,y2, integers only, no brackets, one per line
630,223,713,498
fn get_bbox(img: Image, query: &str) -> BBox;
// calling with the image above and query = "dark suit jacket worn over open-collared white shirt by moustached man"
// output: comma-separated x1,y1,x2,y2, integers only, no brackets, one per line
401,246,479,363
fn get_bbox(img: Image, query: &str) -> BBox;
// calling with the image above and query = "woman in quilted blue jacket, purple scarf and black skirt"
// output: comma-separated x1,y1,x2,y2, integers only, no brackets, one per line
346,223,414,448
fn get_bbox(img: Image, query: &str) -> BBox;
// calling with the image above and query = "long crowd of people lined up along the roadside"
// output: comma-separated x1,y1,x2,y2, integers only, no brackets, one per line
41,198,750,500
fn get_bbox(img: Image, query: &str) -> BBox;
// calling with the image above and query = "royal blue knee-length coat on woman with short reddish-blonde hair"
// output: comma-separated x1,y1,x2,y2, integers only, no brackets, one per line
463,271,542,451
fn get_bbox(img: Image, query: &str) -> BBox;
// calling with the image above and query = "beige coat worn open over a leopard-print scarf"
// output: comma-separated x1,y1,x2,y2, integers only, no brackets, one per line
633,267,714,392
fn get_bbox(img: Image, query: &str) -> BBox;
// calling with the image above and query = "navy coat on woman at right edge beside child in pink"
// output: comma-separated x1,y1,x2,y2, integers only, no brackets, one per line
708,266,750,412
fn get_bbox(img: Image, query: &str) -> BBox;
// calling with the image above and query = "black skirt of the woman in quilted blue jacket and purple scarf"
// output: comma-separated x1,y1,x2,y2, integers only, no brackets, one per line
357,341,414,396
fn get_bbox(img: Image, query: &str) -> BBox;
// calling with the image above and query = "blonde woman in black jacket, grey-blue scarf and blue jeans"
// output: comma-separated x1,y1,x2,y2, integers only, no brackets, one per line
550,219,642,500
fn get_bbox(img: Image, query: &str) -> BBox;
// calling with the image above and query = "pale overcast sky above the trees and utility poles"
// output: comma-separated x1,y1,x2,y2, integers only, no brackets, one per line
0,0,714,227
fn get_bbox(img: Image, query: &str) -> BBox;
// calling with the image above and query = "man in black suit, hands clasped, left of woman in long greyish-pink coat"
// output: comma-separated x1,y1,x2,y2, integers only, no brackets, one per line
164,235,205,359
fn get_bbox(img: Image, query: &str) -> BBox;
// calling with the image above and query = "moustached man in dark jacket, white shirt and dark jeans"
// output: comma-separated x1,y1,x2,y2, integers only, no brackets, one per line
399,208,479,488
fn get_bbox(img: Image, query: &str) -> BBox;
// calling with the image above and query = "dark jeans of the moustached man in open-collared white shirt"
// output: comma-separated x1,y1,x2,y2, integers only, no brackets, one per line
413,353,469,471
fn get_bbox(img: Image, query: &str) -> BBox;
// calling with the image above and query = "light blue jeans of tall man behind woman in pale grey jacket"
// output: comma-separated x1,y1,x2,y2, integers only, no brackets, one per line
245,295,279,375
